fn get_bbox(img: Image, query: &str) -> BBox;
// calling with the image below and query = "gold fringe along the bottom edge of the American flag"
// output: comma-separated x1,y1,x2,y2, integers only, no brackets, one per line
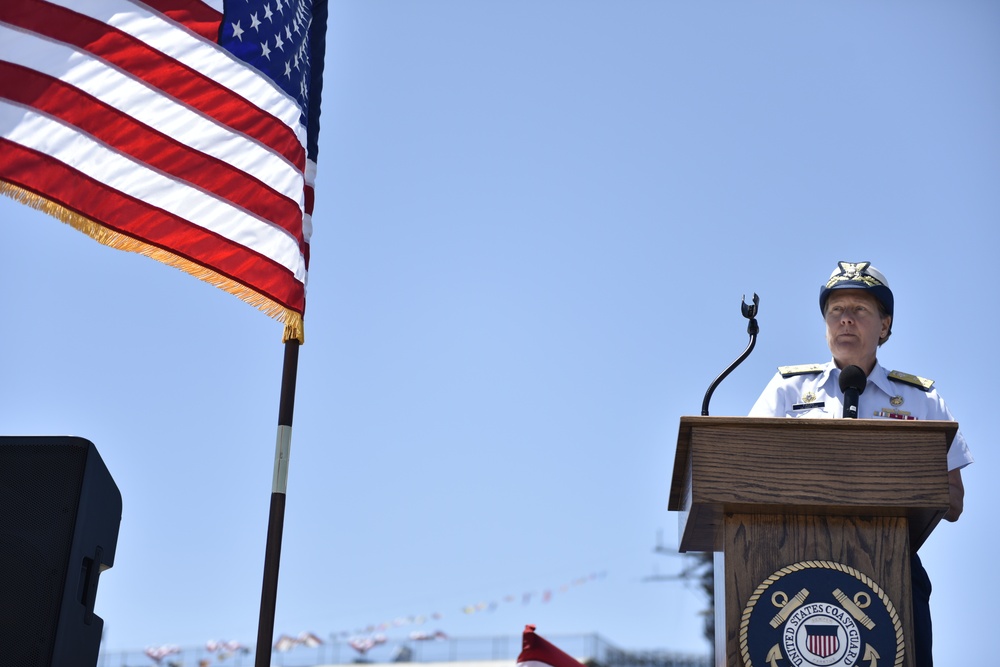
0,181,305,344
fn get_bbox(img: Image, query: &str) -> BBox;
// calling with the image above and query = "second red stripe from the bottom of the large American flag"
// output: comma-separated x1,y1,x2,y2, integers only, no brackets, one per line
0,61,304,244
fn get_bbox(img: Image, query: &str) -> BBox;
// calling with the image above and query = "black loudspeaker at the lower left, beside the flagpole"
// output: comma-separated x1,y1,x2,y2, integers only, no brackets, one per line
0,436,122,667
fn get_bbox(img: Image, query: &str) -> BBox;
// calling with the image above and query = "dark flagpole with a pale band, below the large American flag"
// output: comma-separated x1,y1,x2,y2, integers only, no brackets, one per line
254,337,299,667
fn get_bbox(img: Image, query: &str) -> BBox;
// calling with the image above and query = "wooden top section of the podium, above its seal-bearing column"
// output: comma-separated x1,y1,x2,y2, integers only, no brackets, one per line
668,416,958,551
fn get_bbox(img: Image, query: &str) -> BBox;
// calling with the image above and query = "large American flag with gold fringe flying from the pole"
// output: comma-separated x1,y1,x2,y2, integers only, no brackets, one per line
0,0,327,340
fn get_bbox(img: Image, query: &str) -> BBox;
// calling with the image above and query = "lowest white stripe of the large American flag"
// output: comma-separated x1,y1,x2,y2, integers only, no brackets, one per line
0,100,305,282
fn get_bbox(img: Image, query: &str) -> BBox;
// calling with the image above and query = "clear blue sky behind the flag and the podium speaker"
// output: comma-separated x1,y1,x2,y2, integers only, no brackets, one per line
0,0,1000,664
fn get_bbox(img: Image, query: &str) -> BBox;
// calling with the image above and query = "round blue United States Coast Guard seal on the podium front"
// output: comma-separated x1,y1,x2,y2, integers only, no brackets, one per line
740,561,904,667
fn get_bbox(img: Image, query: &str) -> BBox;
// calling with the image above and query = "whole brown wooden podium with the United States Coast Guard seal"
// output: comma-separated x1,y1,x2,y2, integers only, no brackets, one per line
669,417,958,667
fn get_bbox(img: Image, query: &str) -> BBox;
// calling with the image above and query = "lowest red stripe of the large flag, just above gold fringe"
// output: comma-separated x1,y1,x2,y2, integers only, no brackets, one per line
0,138,305,312
